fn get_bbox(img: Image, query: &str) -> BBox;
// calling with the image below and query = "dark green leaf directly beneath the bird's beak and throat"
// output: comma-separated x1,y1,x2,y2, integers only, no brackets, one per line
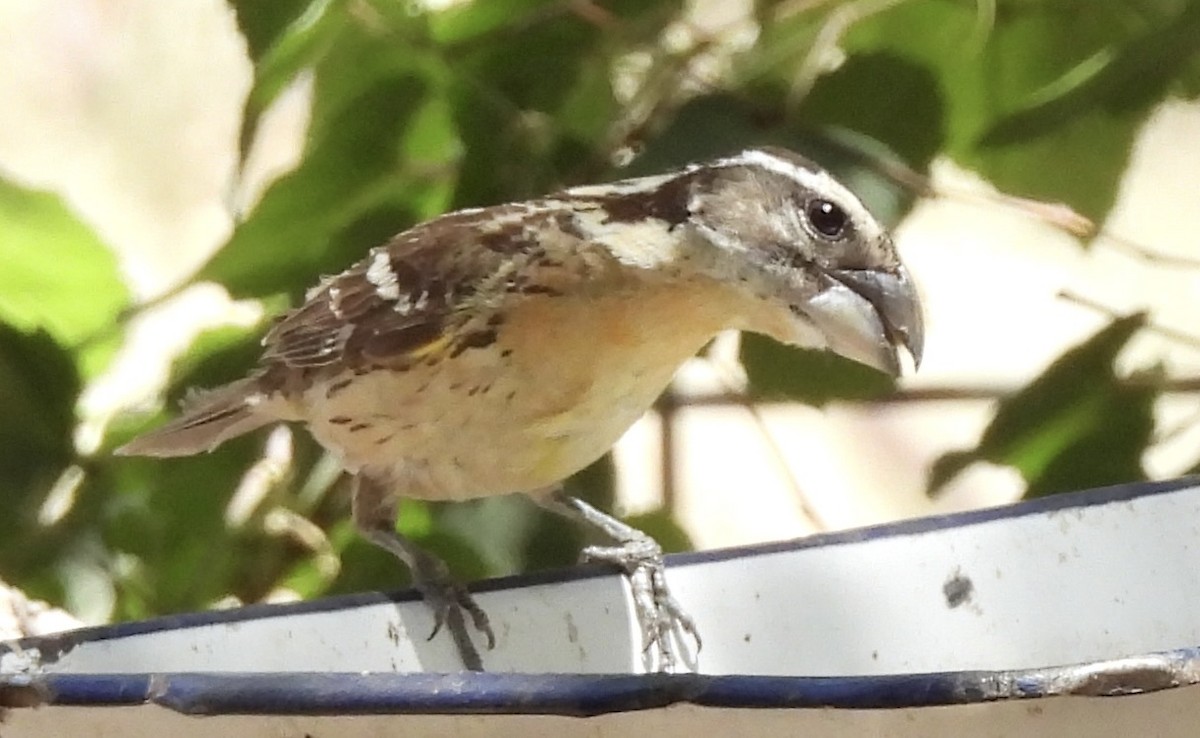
742,334,895,407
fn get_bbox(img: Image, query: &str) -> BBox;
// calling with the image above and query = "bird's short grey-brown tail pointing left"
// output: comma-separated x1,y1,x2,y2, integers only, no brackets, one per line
115,377,278,456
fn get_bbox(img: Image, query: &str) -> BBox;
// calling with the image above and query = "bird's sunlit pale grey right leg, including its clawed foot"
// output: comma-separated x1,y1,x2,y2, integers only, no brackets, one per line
534,488,701,672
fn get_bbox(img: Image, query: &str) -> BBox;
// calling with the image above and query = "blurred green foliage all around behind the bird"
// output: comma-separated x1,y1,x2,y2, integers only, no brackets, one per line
0,0,1200,618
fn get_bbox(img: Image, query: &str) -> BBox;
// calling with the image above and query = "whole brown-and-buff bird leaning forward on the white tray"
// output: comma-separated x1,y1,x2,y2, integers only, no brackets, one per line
116,146,924,671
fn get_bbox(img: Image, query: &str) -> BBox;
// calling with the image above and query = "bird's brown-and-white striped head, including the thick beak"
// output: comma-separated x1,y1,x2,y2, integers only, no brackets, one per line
674,149,924,376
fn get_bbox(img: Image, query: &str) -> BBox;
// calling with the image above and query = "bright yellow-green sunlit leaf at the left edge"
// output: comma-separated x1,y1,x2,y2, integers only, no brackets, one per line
0,180,128,344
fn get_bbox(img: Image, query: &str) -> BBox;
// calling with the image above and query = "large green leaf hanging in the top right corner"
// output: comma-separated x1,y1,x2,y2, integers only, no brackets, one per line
845,0,1196,221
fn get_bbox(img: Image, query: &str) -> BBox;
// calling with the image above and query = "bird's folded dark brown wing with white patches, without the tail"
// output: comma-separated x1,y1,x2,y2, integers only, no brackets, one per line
263,200,604,368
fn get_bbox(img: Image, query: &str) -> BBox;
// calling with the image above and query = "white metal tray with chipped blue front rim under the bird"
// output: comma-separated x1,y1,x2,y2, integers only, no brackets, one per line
0,481,1200,738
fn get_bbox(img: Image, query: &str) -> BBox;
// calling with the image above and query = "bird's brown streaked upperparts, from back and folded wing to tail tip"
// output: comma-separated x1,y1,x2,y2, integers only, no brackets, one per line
119,182,676,456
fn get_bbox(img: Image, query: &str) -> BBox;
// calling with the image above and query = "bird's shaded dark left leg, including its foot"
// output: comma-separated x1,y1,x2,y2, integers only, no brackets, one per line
353,474,496,671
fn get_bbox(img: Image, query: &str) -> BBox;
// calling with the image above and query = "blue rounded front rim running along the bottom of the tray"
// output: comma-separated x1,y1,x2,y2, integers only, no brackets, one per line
9,648,1200,716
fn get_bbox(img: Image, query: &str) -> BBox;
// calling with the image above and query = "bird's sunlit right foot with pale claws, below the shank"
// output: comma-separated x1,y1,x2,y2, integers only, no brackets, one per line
583,528,701,673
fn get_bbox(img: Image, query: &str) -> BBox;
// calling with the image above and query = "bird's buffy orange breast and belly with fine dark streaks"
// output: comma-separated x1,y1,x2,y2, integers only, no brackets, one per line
305,278,736,499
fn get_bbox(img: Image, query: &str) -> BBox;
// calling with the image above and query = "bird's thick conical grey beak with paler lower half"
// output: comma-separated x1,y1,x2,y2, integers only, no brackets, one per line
803,266,925,377
